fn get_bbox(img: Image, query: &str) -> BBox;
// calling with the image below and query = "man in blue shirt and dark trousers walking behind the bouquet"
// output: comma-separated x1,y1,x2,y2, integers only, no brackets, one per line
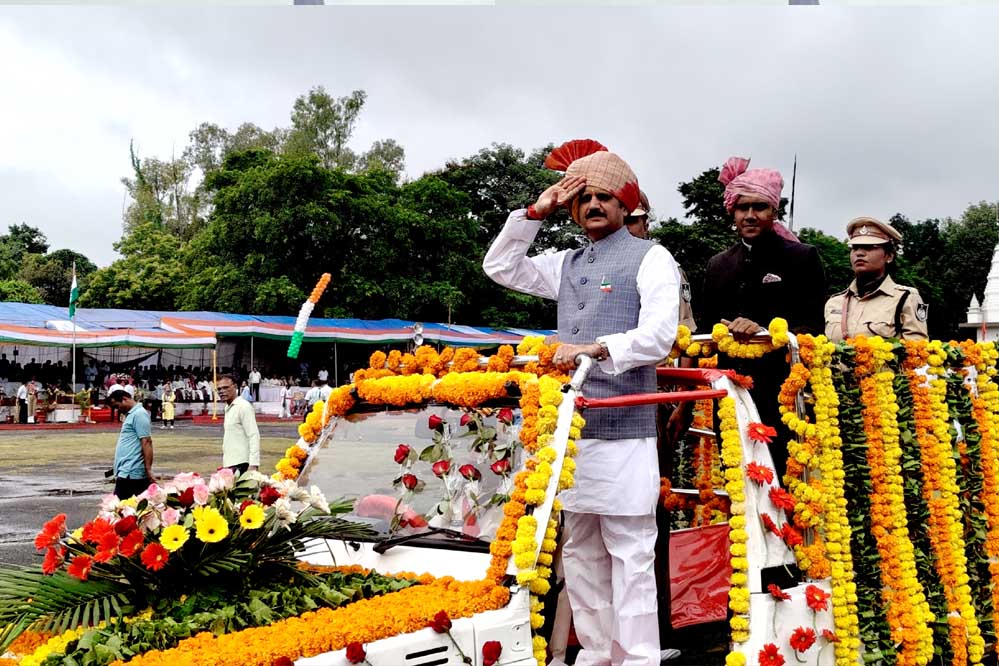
108,389,155,500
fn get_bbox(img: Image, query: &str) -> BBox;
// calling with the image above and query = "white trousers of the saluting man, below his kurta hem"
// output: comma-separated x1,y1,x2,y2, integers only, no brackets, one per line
562,511,659,666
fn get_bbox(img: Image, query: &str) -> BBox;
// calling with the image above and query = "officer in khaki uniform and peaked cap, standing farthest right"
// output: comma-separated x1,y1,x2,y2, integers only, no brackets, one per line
825,217,929,342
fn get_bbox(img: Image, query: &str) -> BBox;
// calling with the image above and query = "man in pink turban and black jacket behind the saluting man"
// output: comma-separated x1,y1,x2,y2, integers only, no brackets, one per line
703,157,826,476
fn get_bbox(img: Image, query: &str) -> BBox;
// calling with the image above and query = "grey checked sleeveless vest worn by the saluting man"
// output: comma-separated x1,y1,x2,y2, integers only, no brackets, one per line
558,227,656,439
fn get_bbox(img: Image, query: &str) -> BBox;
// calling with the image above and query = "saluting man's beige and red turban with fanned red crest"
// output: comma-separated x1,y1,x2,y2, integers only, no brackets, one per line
545,139,640,212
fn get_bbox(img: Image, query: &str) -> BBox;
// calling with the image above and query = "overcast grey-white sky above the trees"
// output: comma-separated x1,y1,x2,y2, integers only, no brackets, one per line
0,5,999,265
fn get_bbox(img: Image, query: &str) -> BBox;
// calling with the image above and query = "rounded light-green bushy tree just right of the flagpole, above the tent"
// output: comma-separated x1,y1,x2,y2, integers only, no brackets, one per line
80,222,186,310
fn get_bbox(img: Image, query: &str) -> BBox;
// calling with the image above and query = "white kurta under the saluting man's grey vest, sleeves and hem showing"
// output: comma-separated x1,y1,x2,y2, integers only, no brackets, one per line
482,210,680,516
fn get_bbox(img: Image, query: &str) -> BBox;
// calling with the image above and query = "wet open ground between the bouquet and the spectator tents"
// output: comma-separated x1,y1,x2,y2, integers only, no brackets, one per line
0,422,298,564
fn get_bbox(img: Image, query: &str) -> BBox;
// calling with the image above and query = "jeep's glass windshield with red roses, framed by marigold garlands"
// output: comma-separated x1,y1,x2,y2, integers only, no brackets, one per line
299,405,523,545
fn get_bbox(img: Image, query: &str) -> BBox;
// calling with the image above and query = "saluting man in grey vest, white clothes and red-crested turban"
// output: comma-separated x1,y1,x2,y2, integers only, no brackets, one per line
483,140,679,665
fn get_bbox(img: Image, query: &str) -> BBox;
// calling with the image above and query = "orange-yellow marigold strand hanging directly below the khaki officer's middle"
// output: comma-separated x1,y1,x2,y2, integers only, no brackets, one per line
852,336,933,666
